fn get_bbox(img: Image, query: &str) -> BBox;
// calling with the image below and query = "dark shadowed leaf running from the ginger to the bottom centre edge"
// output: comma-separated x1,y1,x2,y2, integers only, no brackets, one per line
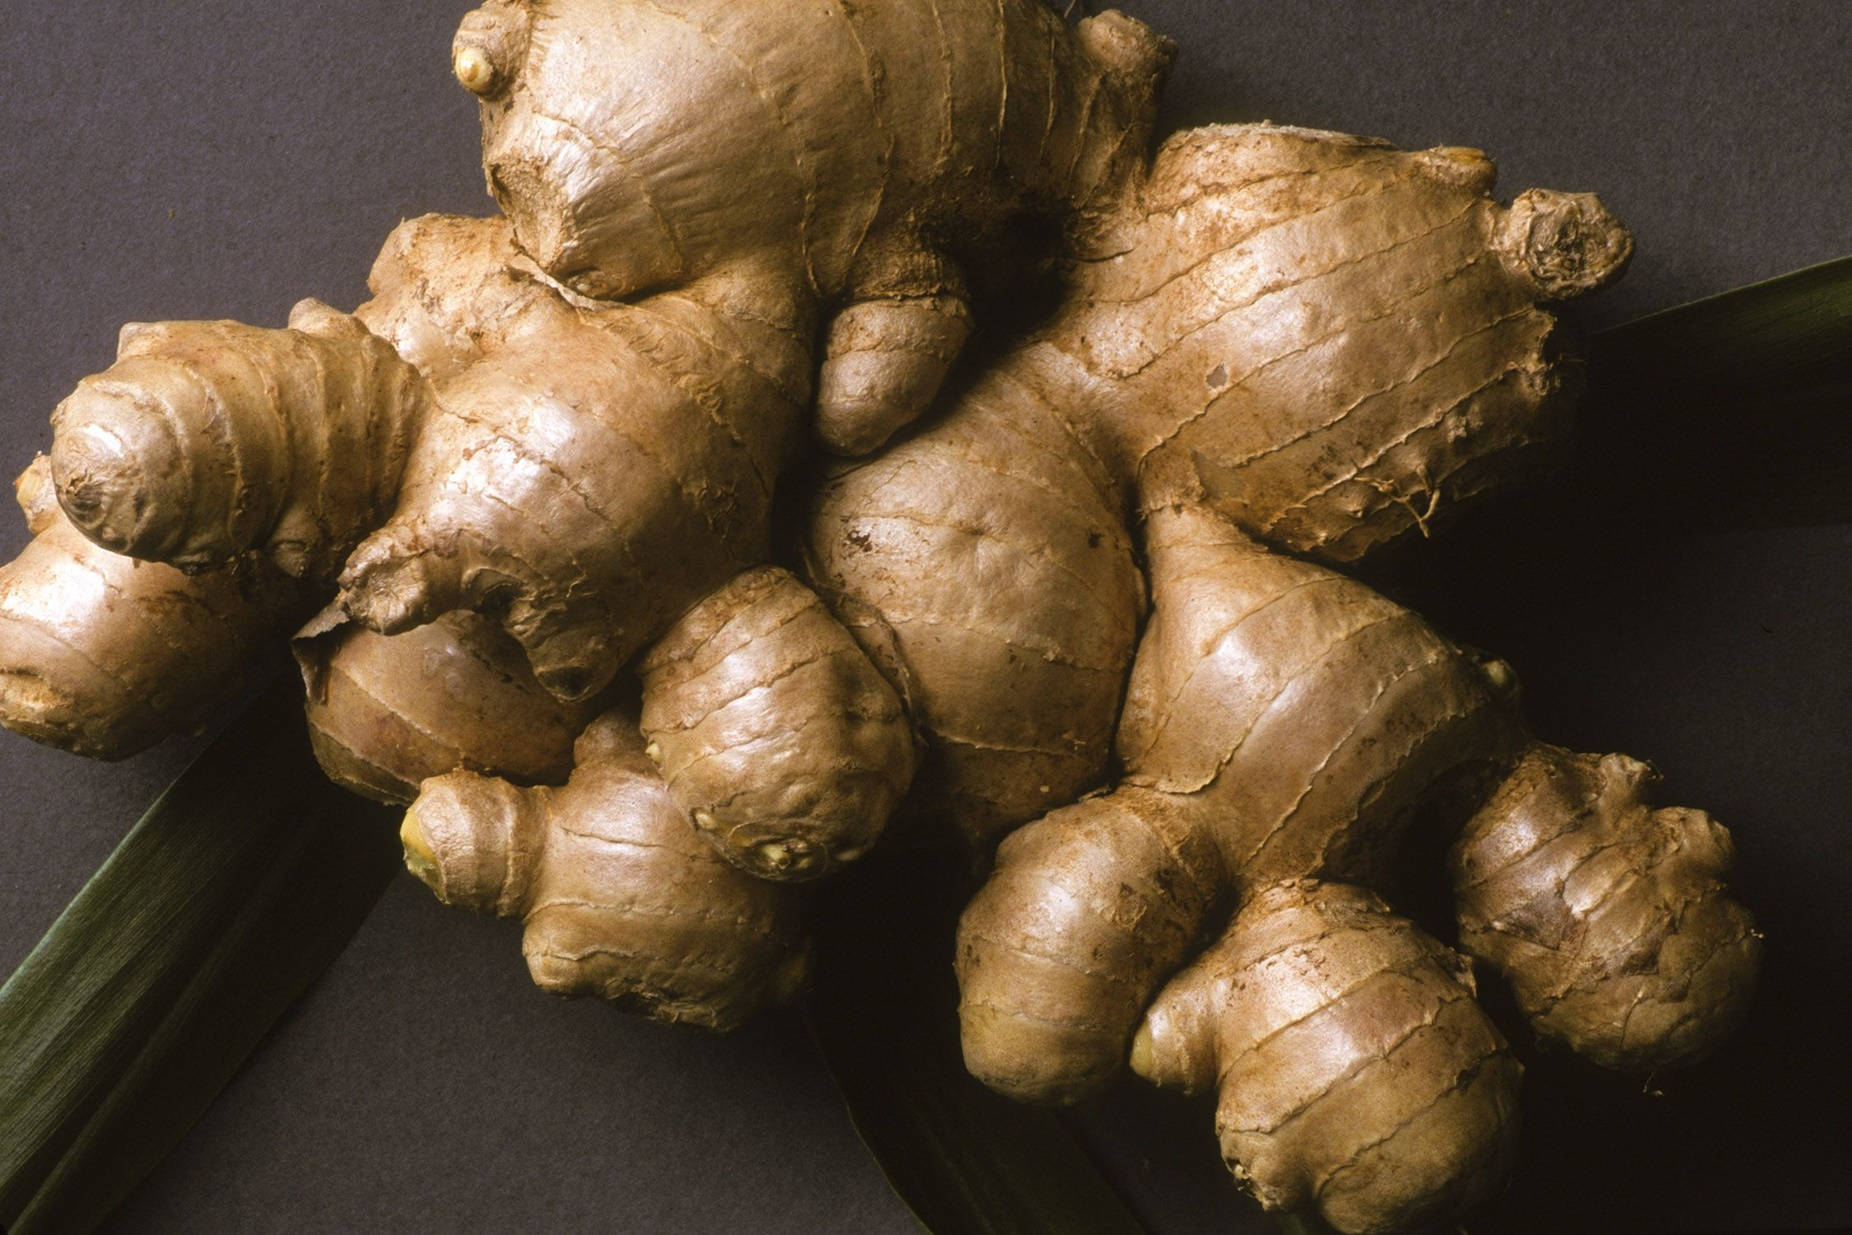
809,850,1145,1235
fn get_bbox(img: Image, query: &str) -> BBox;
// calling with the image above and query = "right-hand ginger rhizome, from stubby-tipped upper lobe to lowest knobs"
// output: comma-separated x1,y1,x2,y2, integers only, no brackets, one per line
806,126,1758,1231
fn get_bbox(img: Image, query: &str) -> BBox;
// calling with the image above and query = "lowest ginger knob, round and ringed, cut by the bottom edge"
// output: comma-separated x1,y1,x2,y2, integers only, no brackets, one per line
1132,881,1522,1231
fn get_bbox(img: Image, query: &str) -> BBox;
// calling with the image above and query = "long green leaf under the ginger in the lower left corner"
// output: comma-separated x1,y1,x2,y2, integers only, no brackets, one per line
0,689,398,1235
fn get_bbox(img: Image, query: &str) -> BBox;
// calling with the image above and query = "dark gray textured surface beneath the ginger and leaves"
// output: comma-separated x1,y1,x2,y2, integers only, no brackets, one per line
0,0,1852,1235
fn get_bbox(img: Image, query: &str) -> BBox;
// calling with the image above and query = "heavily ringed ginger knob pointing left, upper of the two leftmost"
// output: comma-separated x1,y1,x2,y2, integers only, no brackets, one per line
52,300,426,580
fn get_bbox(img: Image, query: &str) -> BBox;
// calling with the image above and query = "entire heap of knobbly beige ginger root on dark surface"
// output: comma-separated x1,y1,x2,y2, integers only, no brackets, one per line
0,0,1759,1231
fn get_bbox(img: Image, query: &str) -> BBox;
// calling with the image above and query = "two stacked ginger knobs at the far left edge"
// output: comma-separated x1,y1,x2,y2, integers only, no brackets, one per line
0,300,426,759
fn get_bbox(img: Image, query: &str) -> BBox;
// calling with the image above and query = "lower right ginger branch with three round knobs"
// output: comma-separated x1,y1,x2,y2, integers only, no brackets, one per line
957,511,1758,1231
